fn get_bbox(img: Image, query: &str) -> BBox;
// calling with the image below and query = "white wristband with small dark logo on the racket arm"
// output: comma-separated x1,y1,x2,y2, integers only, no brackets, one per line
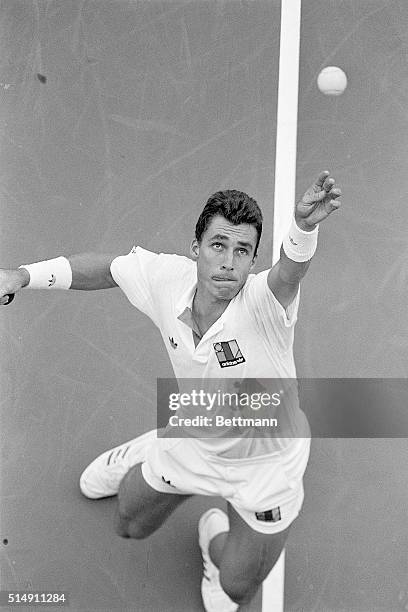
20,257,72,289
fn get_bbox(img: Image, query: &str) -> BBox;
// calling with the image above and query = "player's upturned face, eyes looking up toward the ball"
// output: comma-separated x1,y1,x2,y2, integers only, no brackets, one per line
191,215,258,300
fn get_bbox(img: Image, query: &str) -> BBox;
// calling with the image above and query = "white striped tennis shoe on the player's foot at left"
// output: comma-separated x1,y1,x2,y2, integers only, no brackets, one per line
79,429,157,499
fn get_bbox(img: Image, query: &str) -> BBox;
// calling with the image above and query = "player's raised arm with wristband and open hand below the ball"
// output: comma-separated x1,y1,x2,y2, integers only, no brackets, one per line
268,171,341,308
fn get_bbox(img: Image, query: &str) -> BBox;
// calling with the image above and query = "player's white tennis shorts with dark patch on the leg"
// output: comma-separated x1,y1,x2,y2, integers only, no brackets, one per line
142,438,310,533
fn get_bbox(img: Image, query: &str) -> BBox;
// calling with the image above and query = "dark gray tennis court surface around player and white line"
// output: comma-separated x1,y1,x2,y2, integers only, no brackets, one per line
0,0,408,612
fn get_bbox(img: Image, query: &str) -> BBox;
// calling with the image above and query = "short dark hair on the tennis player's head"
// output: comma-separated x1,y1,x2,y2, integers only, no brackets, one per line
195,189,262,255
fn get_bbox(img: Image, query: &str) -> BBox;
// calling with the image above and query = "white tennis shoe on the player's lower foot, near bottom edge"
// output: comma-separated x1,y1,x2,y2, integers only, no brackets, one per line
198,508,239,612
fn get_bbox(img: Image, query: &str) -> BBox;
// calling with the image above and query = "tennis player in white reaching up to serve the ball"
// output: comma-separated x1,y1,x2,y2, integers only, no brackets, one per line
0,171,341,612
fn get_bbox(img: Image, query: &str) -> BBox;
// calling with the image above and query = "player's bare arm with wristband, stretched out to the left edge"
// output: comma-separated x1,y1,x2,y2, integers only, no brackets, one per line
0,253,117,305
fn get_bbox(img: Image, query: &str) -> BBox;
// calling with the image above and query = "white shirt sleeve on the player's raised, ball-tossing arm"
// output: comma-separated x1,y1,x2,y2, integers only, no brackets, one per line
245,270,299,349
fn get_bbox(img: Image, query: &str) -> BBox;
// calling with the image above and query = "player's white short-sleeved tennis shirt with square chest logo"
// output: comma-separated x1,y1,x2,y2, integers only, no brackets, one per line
111,247,305,457
